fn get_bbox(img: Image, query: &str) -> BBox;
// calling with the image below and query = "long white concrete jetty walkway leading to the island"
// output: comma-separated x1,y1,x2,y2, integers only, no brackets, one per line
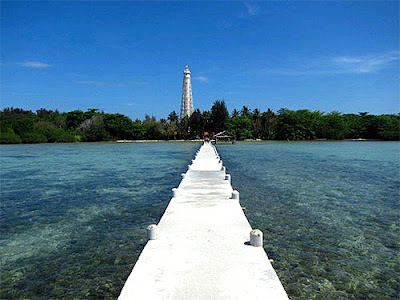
118,143,288,300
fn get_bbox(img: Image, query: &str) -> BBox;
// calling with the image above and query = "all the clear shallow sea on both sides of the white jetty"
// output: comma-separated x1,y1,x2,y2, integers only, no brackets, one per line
0,142,400,300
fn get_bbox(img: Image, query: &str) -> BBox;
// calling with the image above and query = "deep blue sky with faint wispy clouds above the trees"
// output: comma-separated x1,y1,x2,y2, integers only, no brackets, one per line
0,1,399,118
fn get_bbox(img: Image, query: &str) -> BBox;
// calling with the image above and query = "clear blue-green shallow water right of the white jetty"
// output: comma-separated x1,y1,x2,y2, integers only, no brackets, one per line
218,142,400,299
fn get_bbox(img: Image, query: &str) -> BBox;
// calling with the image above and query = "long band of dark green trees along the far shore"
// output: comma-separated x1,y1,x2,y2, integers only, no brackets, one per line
0,101,400,144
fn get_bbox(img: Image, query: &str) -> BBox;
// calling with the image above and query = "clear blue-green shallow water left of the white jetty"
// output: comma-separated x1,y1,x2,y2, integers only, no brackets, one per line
0,143,198,299
